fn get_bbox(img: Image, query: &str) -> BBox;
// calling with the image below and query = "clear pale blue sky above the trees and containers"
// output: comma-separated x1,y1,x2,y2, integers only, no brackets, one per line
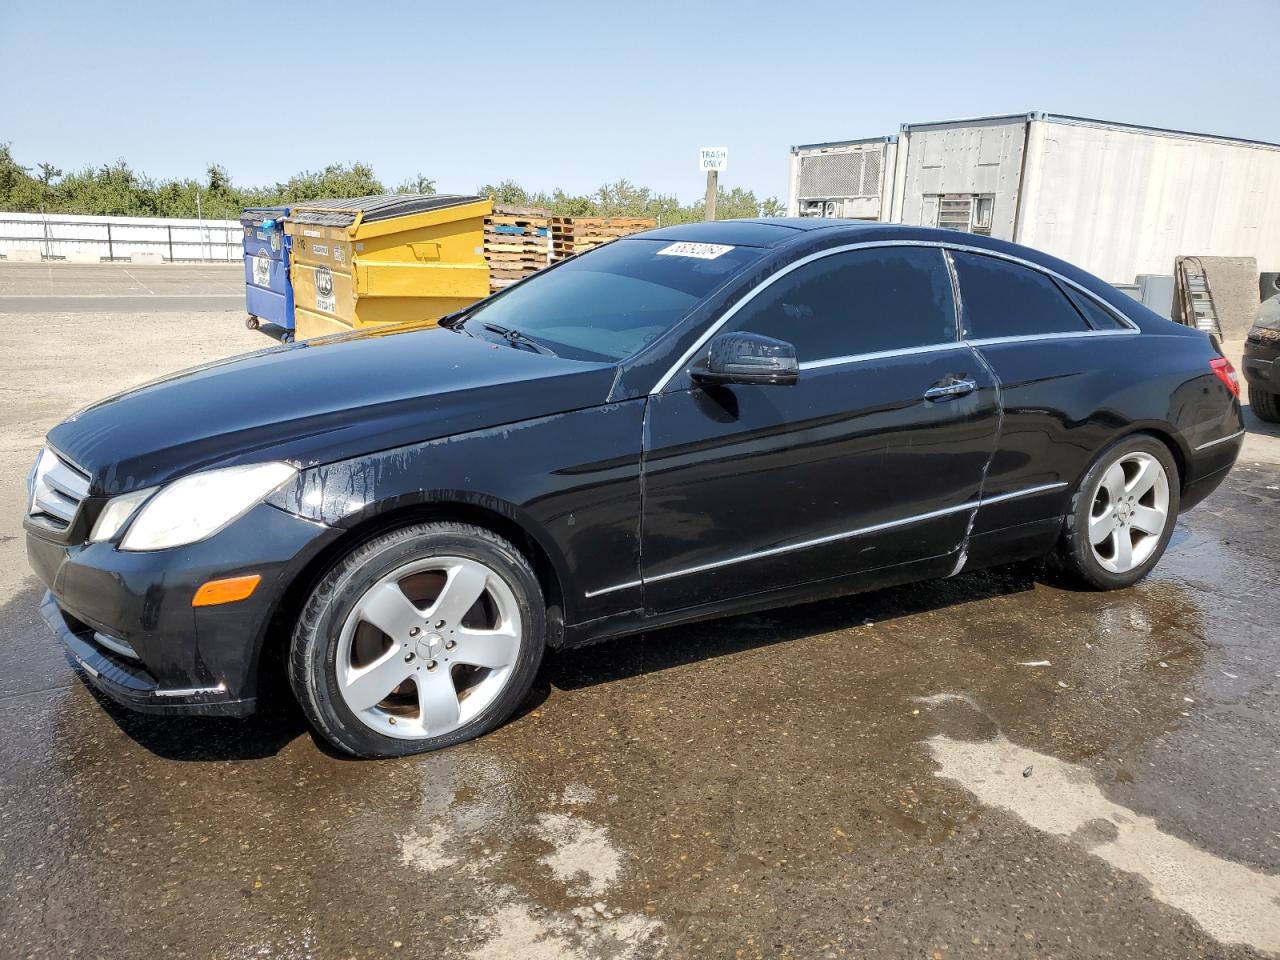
0,0,1280,201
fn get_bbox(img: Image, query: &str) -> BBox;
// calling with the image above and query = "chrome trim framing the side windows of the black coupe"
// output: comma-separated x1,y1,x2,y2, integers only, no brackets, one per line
649,239,1142,397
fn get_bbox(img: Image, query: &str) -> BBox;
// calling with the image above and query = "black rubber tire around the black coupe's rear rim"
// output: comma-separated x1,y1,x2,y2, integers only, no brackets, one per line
1056,434,1181,590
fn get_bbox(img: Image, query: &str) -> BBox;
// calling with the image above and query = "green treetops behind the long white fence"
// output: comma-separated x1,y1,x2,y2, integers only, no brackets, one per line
0,143,783,224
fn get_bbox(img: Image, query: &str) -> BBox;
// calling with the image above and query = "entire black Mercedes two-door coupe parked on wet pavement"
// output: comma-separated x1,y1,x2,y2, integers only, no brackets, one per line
26,220,1243,756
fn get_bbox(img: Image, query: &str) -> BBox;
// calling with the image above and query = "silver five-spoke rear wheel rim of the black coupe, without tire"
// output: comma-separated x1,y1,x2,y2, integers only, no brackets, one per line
1089,451,1169,573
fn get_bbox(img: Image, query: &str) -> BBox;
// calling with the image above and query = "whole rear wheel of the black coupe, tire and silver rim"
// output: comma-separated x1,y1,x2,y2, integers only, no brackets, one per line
1057,434,1179,590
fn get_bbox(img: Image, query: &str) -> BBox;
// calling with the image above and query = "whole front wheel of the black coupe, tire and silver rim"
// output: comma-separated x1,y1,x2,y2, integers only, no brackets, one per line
289,522,545,756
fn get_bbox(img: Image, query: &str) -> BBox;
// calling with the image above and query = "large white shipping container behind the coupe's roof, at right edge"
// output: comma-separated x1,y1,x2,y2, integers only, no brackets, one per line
890,113,1280,283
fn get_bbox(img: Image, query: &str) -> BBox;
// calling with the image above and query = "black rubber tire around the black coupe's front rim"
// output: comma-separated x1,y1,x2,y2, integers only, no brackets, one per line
288,522,547,758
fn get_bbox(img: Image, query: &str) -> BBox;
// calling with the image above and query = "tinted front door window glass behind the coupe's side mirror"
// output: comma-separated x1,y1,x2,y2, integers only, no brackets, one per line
726,247,956,362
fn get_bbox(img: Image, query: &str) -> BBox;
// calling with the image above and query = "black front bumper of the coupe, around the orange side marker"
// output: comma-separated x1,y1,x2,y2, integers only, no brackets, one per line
27,504,338,716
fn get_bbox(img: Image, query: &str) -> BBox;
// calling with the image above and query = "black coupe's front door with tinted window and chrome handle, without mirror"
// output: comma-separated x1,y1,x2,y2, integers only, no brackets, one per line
641,244,998,612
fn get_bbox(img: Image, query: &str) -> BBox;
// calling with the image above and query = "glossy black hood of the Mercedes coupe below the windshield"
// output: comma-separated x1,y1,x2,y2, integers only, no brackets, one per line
49,325,616,497
